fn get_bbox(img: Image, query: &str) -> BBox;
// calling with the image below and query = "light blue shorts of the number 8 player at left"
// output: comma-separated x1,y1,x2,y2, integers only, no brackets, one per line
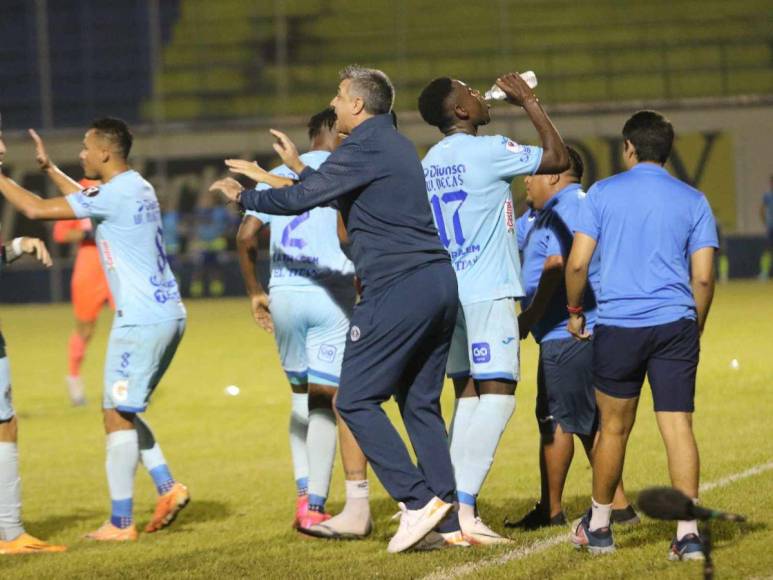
102,318,185,413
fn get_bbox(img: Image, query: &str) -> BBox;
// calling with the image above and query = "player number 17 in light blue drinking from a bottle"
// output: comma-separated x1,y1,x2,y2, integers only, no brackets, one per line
419,73,569,544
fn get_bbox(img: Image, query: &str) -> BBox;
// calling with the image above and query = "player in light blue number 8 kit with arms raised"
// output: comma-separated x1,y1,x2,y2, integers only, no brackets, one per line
0,118,189,541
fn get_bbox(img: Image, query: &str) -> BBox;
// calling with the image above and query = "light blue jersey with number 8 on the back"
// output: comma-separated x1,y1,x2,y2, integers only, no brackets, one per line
65,170,185,327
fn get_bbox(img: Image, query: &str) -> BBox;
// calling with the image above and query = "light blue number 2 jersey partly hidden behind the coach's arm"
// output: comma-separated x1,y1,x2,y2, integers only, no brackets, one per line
247,151,354,292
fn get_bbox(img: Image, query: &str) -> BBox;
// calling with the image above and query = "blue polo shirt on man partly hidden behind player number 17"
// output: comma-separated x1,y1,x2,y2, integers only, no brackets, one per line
522,183,600,343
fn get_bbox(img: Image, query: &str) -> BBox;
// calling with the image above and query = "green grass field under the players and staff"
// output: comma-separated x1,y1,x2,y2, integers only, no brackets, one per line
0,282,773,579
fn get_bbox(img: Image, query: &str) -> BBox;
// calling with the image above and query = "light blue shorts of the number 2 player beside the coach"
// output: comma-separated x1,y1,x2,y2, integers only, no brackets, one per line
269,289,354,387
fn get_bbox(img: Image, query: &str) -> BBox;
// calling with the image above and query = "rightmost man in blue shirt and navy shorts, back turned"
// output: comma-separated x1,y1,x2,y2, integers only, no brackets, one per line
566,111,719,560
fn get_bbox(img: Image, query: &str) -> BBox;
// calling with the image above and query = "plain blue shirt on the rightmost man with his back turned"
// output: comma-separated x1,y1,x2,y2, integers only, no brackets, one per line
576,163,719,328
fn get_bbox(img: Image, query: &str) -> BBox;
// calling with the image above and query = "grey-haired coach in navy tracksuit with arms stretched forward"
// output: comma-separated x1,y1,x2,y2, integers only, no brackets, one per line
213,67,458,552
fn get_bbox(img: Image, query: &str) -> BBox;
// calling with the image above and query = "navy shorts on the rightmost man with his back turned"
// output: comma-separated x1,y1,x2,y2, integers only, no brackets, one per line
593,319,700,413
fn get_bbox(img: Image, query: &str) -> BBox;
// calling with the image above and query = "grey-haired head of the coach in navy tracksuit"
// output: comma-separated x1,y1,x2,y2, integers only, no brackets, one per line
330,65,395,135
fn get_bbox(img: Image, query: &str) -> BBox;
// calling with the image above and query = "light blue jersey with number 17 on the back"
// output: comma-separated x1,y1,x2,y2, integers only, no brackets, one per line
422,133,542,305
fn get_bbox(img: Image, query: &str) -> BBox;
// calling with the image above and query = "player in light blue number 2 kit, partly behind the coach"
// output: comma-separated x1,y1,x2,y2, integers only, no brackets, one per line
228,108,372,538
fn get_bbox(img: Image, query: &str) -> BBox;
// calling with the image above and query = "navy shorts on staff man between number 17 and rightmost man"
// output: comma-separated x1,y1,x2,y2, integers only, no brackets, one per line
535,338,596,435
